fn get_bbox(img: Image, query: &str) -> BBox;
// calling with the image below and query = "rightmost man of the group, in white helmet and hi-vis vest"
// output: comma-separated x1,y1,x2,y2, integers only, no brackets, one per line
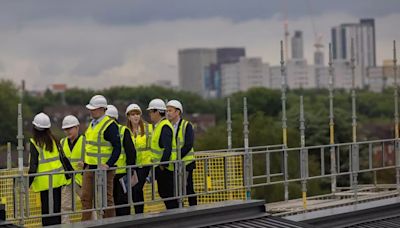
167,100,197,206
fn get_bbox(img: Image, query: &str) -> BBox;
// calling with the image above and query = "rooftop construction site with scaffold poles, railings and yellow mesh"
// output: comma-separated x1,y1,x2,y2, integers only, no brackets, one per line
0,36,400,228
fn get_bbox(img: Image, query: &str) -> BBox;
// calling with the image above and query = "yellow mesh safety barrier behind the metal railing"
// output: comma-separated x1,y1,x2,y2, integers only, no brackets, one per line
0,153,246,227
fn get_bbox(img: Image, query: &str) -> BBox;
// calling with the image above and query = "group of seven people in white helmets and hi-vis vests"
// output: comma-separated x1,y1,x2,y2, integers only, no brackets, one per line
28,95,197,226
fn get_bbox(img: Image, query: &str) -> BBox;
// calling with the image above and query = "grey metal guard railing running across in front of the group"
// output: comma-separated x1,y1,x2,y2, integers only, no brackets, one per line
0,136,399,225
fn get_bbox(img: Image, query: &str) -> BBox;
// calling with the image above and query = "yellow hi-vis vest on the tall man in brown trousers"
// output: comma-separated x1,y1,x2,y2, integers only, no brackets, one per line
85,116,114,165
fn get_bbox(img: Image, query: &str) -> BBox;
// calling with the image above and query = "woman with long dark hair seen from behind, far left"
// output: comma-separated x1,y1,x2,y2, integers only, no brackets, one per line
28,113,67,226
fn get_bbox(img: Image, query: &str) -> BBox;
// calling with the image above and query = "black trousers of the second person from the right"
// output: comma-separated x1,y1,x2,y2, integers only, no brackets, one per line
156,167,179,209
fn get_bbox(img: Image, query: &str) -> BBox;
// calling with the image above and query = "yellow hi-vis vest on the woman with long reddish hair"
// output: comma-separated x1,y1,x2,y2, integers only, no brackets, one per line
132,122,153,166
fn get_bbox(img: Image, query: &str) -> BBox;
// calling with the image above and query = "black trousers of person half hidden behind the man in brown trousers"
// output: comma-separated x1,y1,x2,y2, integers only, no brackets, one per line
113,173,131,216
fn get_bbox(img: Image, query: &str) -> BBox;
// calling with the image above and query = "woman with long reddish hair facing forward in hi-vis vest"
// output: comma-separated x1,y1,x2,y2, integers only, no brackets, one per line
125,104,153,214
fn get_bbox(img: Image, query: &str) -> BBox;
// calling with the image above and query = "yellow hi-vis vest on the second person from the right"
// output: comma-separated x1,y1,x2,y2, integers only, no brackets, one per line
150,119,176,171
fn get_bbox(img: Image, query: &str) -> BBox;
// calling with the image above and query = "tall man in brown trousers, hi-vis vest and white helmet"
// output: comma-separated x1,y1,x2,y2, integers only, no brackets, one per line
81,95,121,221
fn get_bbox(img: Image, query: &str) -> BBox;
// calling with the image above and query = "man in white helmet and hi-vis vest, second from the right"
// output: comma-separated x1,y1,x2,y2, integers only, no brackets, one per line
147,99,179,209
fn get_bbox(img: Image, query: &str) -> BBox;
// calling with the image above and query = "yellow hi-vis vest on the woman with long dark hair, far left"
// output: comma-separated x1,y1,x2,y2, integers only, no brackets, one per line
31,139,67,192
